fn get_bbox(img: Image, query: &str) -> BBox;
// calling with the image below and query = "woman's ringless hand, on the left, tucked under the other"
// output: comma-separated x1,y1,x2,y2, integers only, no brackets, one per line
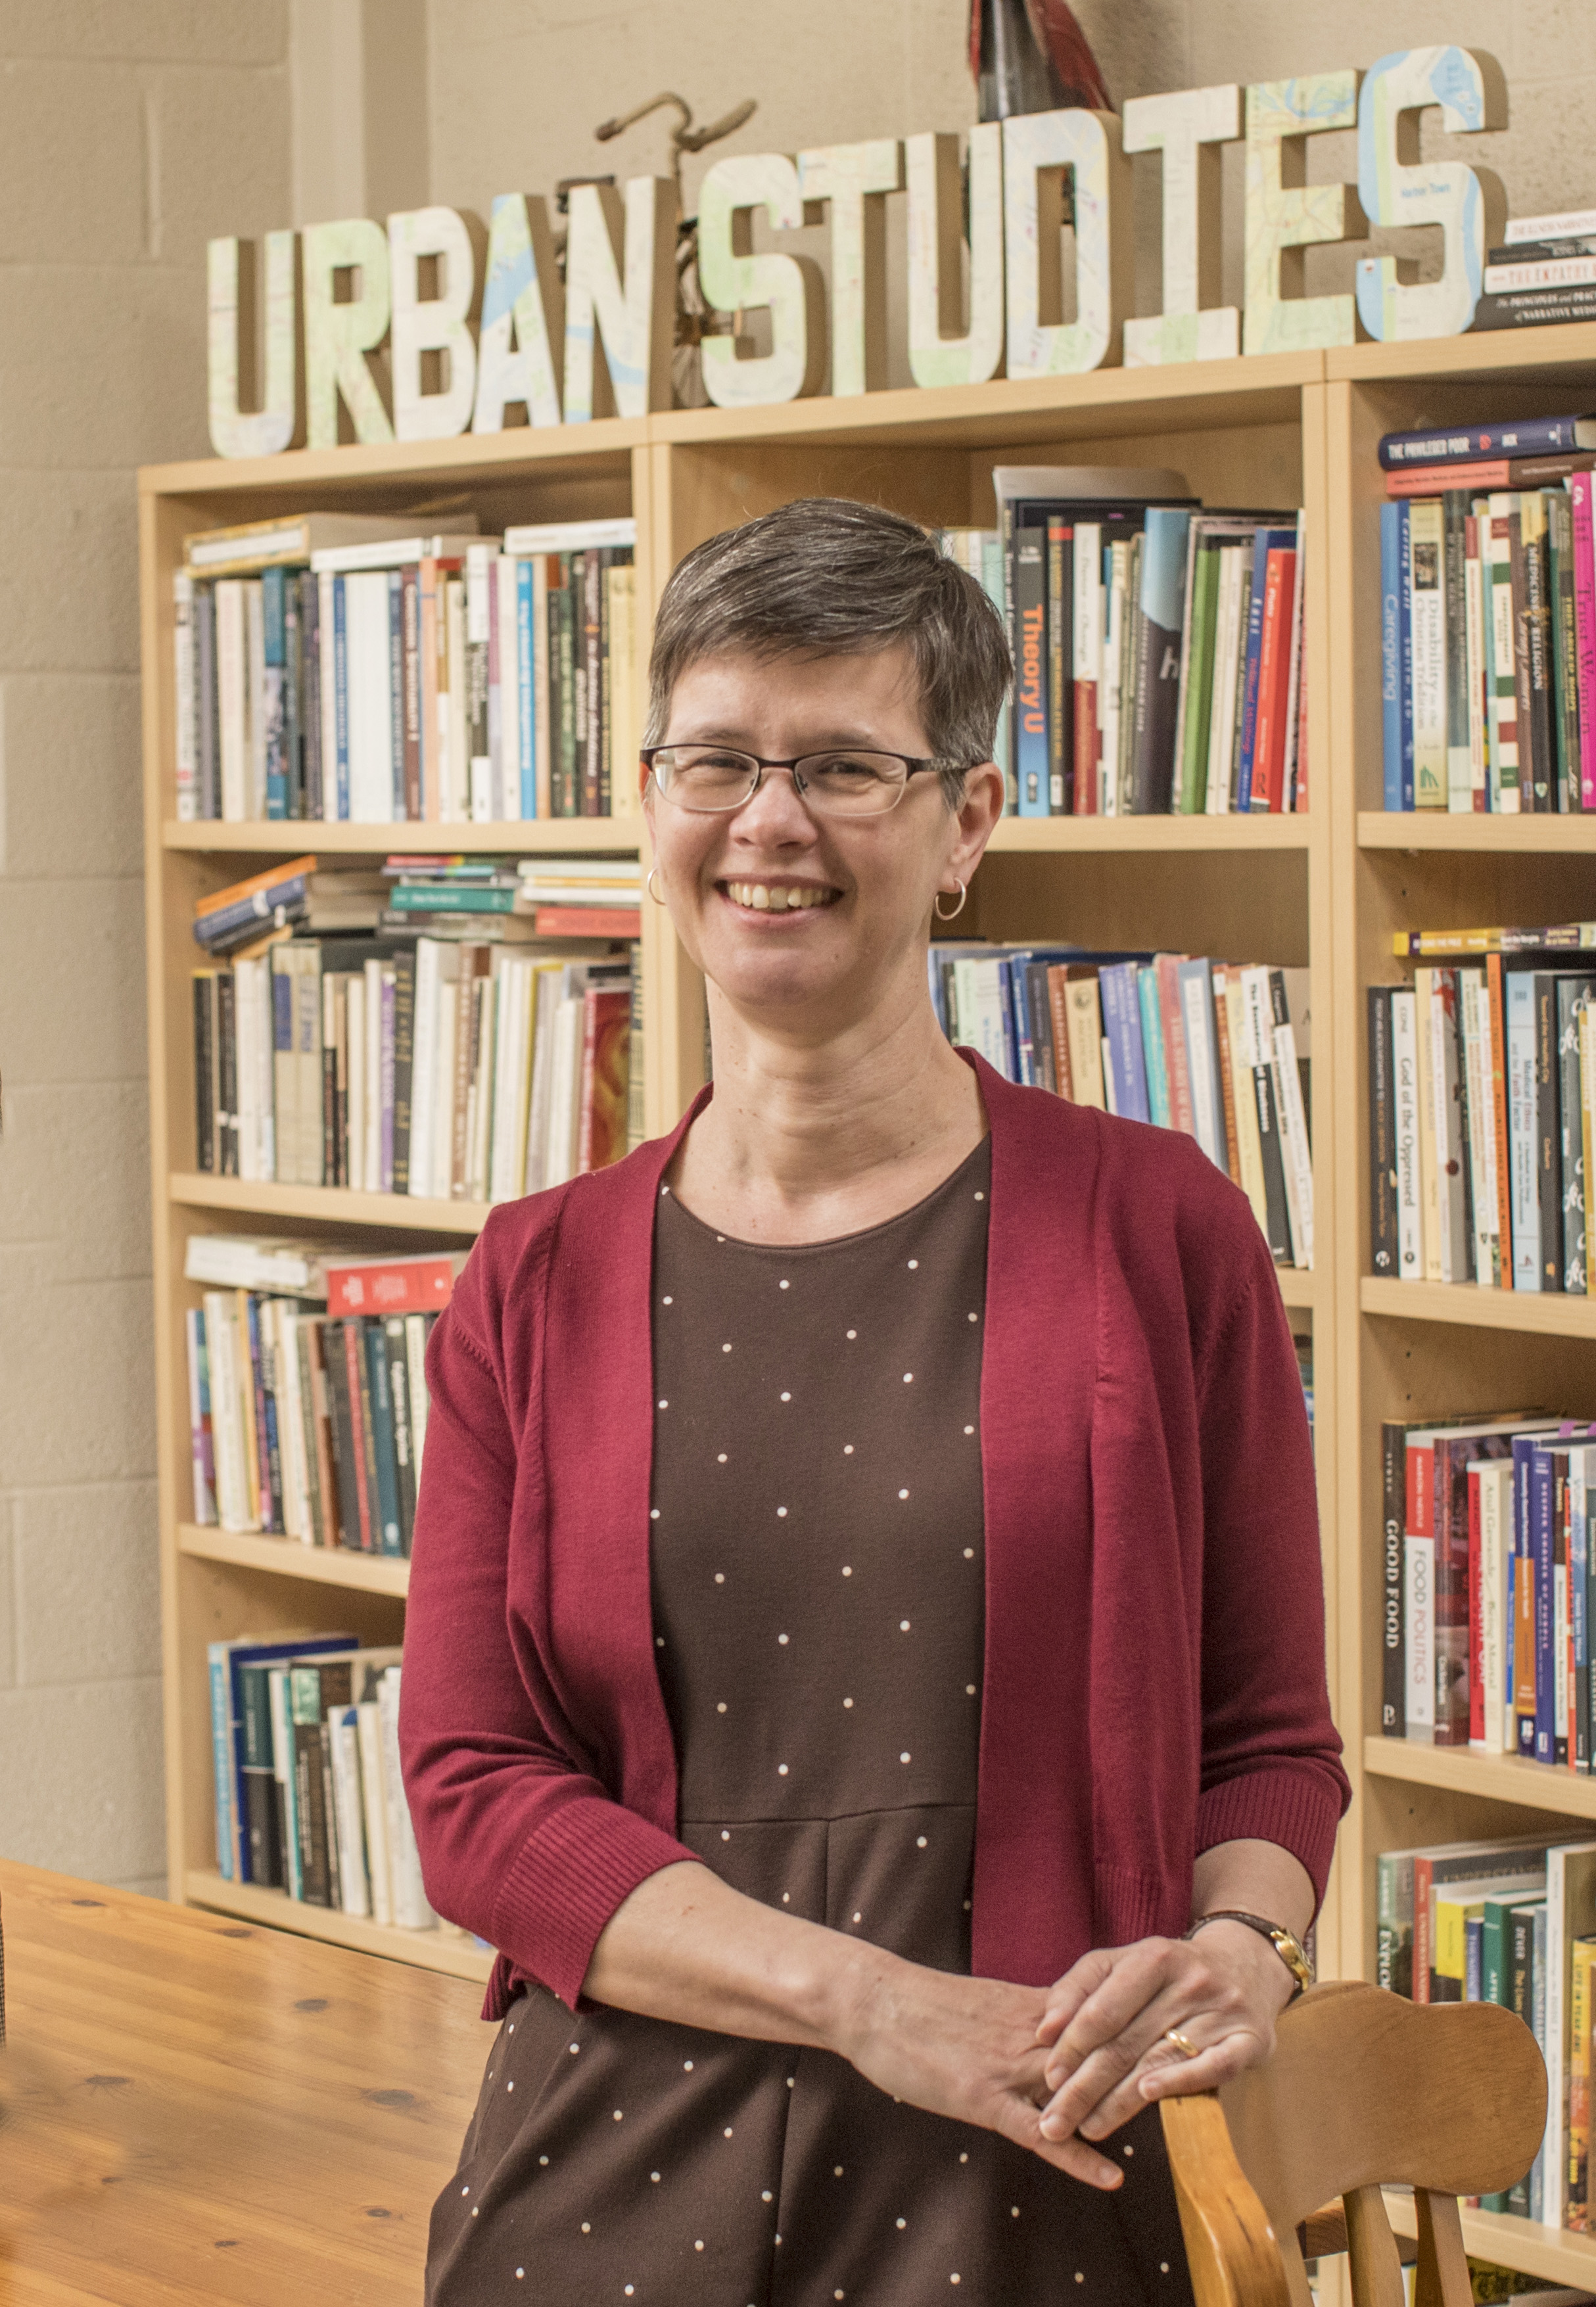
828,1947,1130,2189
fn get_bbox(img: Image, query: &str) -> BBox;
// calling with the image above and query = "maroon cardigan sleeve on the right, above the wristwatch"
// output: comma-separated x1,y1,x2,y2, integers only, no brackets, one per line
1197,1216,1351,1899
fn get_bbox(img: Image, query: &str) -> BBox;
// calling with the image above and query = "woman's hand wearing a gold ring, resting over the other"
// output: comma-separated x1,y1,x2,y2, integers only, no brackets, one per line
1035,1922,1292,2168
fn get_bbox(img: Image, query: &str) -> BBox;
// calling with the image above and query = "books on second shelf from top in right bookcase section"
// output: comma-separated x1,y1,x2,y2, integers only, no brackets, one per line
1368,923,1596,1297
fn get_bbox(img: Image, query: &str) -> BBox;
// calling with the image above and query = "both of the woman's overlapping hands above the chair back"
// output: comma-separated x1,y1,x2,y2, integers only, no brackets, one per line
835,1924,1292,2187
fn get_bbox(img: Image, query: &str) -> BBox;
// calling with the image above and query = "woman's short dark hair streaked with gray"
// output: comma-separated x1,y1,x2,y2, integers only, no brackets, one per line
644,496,1012,805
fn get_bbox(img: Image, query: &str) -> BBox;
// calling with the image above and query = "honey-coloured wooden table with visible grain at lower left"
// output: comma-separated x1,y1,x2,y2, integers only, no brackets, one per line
0,1862,491,2307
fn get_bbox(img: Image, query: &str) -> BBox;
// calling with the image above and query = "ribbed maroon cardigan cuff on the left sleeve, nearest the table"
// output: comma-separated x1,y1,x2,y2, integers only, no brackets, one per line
489,1795,701,2009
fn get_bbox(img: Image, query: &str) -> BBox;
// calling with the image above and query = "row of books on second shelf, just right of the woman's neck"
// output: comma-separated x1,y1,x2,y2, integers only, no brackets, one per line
929,941,1312,1267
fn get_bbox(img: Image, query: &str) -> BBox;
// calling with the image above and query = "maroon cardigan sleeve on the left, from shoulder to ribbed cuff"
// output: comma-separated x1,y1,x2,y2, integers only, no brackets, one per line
399,1221,697,2009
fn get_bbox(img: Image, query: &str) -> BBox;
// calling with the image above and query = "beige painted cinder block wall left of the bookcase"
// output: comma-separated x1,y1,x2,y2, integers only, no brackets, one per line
0,0,291,1892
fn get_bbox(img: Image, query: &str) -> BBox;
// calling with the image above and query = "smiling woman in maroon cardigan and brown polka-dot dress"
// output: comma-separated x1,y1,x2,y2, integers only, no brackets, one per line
402,498,1347,2307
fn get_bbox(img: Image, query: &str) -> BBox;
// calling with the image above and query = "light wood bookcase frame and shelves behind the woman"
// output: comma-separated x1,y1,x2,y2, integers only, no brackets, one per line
141,327,1596,2281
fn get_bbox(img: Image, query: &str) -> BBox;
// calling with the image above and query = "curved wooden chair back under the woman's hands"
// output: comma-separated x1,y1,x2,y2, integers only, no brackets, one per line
1162,1980,1545,2307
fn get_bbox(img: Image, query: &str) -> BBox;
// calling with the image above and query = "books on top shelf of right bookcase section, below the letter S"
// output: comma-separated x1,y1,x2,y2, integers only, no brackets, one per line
1379,415,1596,814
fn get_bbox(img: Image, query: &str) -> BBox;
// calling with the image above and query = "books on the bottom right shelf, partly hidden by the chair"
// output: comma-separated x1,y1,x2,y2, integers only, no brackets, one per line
1374,1836,1596,2233
